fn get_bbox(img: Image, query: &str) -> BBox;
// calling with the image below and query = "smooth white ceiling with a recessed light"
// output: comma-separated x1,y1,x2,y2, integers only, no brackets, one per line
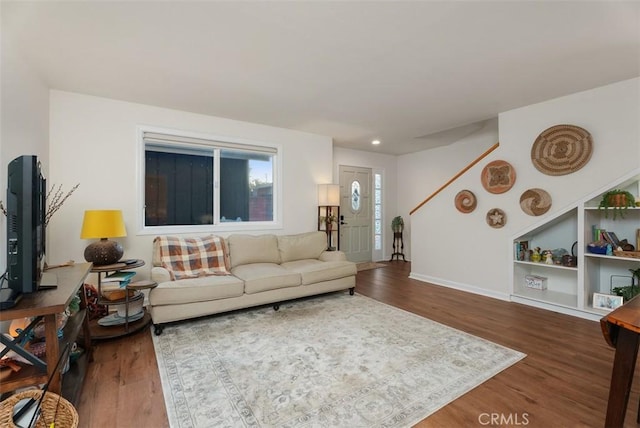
1,1,640,154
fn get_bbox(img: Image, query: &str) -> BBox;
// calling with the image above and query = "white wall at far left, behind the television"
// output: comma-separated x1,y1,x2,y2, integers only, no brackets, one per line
0,43,49,272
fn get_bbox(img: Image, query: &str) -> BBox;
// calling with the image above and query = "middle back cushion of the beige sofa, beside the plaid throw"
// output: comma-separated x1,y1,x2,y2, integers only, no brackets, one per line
228,234,280,268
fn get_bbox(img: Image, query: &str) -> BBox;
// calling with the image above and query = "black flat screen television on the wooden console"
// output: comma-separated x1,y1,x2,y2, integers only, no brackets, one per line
0,155,47,307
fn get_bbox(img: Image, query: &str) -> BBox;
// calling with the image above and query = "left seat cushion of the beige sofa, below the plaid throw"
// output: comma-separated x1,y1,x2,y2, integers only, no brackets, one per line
149,276,244,306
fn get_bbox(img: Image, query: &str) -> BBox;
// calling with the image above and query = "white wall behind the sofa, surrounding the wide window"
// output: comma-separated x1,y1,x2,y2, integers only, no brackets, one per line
49,91,333,278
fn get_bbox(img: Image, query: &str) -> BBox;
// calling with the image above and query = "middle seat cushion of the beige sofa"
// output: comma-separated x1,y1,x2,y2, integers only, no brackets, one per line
231,263,300,294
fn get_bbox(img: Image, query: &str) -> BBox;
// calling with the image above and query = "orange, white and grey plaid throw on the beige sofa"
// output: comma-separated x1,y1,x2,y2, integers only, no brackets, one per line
155,235,231,280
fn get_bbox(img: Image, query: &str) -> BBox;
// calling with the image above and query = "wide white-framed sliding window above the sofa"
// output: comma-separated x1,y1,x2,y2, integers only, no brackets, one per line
142,131,278,230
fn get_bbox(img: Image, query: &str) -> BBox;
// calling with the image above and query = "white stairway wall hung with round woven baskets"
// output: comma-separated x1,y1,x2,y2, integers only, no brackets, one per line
408,78,640,299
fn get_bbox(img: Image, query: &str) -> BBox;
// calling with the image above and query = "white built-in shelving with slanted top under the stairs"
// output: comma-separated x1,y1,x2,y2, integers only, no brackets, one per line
510,170,640,320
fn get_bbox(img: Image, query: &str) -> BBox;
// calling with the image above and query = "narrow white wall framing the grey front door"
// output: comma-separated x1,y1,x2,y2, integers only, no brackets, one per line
333,147,398,261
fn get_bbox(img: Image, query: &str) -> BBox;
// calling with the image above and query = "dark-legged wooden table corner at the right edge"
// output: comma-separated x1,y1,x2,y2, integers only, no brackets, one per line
600,296,640,428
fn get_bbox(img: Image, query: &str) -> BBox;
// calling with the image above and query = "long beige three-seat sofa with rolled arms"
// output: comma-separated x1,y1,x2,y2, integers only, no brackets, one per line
149,232,357,335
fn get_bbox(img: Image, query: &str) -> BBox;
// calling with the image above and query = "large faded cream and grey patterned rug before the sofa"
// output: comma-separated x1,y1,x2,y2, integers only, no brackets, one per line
152,293,525,428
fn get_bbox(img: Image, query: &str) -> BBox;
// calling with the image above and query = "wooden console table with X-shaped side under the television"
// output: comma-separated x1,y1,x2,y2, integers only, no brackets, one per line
0,263,92,403
